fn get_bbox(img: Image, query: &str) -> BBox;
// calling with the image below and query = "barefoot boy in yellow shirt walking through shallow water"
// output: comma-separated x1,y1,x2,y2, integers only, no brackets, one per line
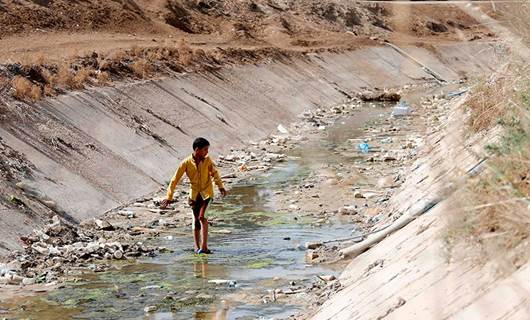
160,138,227,254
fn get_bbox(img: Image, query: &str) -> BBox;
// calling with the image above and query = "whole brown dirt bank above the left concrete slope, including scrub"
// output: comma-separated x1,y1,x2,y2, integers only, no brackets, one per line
0,0,493,101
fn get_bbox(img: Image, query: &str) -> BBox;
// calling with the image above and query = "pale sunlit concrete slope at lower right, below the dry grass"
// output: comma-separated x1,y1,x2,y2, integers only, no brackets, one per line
313,97,530,320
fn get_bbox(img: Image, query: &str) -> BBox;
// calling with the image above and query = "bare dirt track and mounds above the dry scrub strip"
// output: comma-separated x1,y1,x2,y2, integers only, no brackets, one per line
0,0,487,64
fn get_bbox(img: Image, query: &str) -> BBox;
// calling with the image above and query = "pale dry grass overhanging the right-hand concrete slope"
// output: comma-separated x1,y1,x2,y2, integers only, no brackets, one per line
447,18,530,274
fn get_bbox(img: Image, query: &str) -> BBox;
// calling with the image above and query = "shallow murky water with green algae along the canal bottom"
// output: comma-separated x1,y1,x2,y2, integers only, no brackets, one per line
0,107,389,319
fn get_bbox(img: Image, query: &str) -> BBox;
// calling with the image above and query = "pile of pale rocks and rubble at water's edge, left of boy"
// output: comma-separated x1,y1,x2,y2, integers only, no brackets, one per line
0,215,163,285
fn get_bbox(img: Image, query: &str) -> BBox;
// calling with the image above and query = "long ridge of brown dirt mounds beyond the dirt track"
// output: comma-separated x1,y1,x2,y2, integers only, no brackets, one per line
0,0,486,41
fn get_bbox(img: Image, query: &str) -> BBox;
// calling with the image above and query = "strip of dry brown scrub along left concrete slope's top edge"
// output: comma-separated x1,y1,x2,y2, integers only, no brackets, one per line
3,40,300,102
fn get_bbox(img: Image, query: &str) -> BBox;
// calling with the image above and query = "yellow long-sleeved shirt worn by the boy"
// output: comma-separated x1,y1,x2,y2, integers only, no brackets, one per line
166,155,224,200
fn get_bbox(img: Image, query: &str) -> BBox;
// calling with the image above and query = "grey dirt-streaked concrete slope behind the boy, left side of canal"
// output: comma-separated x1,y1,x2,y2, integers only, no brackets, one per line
0,42,498,252
